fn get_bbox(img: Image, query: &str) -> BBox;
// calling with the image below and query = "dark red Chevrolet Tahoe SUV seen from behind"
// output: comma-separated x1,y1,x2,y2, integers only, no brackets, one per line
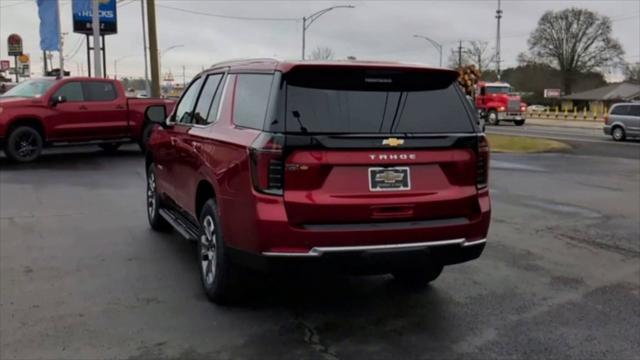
146,59,490,302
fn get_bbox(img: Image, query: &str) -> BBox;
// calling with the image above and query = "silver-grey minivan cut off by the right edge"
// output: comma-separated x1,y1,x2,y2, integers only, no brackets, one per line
603,103,640,141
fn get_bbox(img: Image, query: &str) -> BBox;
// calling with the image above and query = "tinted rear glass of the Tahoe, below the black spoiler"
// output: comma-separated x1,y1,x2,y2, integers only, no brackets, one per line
285,83,475,133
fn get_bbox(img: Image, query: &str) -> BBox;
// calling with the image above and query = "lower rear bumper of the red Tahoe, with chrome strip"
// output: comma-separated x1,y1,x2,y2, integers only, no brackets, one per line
223,190,491,272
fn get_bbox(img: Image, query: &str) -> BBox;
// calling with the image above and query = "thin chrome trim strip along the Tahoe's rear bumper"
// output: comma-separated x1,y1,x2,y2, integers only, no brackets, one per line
262,239,487,257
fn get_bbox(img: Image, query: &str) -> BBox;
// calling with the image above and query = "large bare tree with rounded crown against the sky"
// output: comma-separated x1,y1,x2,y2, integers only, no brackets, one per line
528,8,624,94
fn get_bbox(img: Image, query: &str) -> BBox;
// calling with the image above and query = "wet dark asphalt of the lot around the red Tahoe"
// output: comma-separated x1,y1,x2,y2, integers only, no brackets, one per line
0,139,640,359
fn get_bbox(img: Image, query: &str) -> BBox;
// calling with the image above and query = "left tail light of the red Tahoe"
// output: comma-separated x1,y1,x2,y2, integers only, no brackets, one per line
249,133,284,195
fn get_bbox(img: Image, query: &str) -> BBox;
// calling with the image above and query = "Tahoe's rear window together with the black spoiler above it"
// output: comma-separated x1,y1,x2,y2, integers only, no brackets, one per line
282,66,475,134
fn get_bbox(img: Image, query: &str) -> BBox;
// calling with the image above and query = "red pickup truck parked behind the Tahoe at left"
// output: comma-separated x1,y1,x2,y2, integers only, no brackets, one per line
0,77,174,162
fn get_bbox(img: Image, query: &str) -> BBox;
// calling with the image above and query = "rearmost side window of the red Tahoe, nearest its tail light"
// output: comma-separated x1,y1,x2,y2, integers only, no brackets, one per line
233,74,273,130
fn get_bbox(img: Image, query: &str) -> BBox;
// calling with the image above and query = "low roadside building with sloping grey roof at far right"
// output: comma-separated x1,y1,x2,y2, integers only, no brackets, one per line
560,82,640,114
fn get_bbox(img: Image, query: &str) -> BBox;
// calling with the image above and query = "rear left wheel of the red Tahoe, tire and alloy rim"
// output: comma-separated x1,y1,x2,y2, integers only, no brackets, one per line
197,199,240,305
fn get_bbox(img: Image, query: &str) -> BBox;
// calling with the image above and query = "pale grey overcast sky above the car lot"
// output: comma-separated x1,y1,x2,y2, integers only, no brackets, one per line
0,0,640,81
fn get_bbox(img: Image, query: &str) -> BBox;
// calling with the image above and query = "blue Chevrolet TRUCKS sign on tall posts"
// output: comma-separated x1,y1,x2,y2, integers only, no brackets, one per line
71,0,118,35
